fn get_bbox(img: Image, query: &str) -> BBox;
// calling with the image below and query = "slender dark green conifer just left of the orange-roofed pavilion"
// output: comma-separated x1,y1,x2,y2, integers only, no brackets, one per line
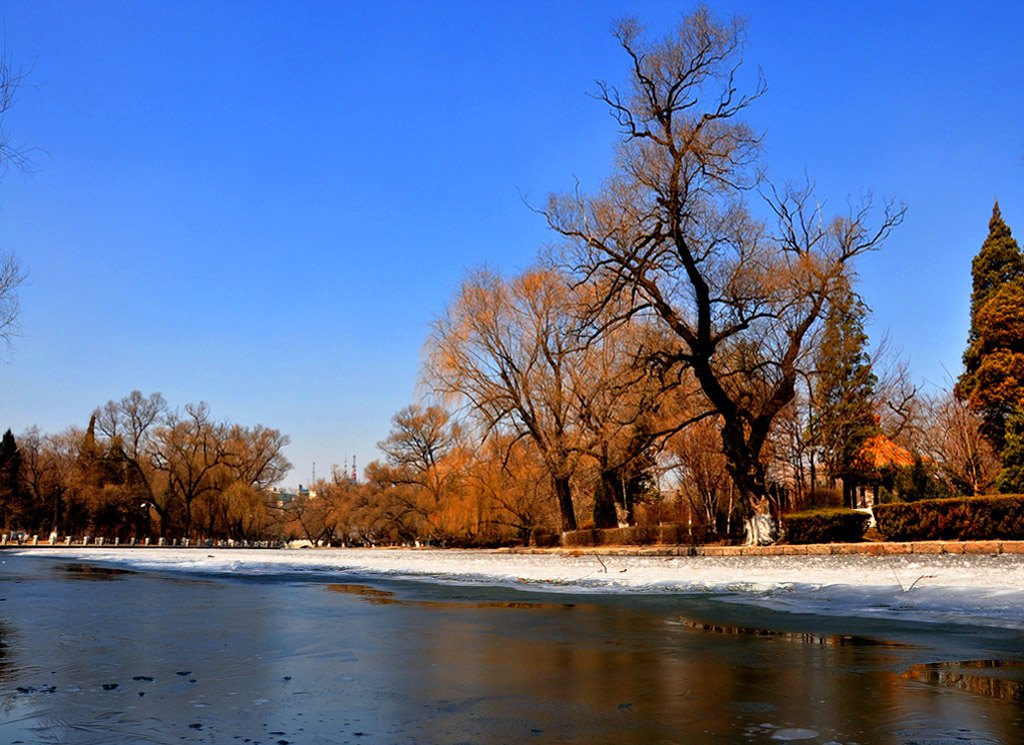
811,277,878,505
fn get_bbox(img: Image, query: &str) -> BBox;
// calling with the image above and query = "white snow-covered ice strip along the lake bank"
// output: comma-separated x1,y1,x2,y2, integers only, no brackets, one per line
11,547,1024,628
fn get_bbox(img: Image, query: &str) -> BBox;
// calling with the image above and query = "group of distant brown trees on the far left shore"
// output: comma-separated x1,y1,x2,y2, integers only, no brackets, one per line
0,391,291,540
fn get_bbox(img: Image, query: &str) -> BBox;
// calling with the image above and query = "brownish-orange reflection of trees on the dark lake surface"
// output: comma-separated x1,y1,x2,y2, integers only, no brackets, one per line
373,603,925,745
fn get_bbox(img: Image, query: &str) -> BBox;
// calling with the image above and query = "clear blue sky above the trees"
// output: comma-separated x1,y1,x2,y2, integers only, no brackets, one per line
0,0,1024,486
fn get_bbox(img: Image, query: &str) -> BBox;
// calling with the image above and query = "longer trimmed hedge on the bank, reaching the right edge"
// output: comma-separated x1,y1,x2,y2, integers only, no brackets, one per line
874,494,1024,540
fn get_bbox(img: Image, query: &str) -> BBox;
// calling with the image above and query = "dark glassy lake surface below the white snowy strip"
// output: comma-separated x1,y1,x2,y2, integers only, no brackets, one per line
0,558,1021,745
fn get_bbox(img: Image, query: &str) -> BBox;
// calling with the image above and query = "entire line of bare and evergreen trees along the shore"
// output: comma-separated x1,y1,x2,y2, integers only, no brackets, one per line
0,8,1024,545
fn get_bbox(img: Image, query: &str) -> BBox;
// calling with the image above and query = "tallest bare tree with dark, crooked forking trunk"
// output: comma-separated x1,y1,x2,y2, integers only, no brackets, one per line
545,8,903,514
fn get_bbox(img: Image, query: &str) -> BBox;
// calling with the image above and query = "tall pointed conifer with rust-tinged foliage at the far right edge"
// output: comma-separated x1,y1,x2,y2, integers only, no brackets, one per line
956,202,1024,452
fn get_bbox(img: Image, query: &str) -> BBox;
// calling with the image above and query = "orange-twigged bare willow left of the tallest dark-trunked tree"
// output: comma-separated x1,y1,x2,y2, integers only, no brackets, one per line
426,269,582,530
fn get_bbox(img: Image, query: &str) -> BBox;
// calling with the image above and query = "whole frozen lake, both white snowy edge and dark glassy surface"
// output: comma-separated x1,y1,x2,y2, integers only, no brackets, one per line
0,549,1024,745
